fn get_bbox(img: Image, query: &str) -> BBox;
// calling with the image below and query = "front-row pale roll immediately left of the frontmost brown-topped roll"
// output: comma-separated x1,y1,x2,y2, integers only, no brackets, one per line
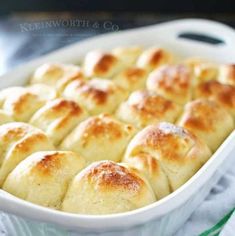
3,151,85,209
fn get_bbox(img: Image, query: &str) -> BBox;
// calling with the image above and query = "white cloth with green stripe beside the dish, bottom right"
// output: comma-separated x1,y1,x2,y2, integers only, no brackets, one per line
176,164,235,236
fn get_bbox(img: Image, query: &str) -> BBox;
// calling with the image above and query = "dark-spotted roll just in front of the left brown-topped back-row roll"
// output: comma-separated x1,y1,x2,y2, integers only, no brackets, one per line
63,79,126,115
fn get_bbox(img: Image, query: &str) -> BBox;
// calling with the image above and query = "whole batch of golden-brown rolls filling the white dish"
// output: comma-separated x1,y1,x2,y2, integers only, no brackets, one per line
0,46,235,215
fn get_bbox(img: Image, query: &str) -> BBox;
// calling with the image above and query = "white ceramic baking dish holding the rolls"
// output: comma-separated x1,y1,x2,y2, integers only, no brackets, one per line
0,19,235,236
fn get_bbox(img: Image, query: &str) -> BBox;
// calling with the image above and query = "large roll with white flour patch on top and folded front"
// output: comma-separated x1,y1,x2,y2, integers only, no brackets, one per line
124,122,211,198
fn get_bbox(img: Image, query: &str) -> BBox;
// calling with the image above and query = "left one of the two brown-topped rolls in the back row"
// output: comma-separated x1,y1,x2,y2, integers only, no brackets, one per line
83,50,125,78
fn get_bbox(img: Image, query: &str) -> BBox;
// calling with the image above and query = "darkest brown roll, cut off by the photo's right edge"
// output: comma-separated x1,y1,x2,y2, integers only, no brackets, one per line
195,80,235,118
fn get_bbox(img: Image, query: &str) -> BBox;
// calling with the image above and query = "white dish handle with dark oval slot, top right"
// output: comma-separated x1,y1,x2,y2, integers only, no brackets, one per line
158,19,235,50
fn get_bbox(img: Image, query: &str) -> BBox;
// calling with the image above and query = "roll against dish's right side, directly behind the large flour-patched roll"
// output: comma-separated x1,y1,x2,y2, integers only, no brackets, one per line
178,99,234,152
